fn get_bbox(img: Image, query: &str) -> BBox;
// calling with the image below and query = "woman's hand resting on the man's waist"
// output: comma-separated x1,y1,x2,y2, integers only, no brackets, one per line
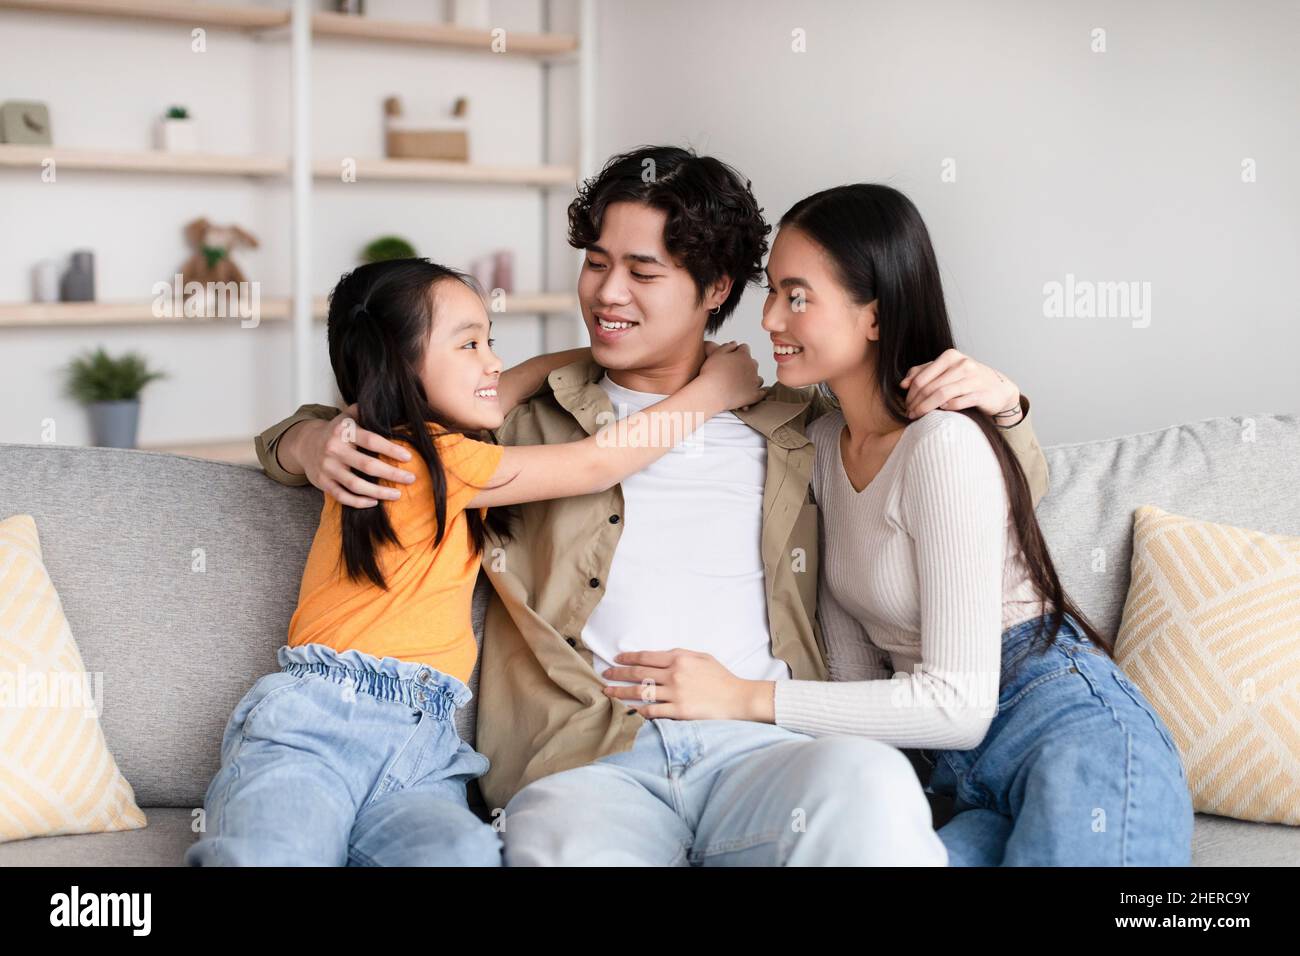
602,648,776,723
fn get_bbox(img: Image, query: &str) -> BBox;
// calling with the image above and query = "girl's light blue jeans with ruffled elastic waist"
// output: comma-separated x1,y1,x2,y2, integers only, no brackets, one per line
185,644,501,866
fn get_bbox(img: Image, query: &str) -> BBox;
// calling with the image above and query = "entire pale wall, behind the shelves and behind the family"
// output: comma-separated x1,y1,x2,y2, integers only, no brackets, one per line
0,0,1300,444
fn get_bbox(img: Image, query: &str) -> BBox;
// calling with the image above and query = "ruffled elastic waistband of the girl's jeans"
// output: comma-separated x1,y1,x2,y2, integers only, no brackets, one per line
276,644,473,718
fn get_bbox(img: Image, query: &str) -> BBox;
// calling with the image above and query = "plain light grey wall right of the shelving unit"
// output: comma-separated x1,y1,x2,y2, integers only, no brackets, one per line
597,0,1300,444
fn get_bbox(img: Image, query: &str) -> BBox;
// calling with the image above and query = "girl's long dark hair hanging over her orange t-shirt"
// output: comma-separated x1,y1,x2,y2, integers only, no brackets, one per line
328,259,511,588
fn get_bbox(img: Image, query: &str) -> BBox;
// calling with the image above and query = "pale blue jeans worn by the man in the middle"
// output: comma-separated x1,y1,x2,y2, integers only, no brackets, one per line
502,718,946,866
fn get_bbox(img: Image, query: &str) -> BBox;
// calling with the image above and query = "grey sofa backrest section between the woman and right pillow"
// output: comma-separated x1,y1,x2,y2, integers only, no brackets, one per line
1037,415,1300,639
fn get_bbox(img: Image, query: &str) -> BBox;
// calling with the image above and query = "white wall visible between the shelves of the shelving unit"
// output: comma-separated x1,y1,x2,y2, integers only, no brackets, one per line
0,0,576,445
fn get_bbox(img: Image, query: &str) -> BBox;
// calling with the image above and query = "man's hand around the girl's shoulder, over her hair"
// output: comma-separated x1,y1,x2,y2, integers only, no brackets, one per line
277,405,415,507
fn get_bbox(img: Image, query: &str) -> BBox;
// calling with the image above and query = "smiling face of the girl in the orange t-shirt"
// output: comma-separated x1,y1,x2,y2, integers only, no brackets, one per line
420,280,504,429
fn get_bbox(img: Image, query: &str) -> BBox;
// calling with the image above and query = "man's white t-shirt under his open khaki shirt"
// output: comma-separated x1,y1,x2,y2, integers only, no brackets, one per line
582,375,790,704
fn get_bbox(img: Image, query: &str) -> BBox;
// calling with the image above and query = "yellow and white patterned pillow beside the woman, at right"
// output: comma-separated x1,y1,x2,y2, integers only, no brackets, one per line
1115,505,1300,826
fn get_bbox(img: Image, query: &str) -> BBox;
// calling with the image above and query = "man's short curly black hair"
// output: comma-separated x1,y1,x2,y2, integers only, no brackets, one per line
568,146,772,334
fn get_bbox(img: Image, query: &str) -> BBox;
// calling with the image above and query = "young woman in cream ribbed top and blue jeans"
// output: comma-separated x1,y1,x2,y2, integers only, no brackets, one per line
606,185,1192,866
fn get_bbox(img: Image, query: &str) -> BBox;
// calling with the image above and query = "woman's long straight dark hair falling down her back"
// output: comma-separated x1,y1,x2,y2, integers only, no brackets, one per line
781,183,1112,653
